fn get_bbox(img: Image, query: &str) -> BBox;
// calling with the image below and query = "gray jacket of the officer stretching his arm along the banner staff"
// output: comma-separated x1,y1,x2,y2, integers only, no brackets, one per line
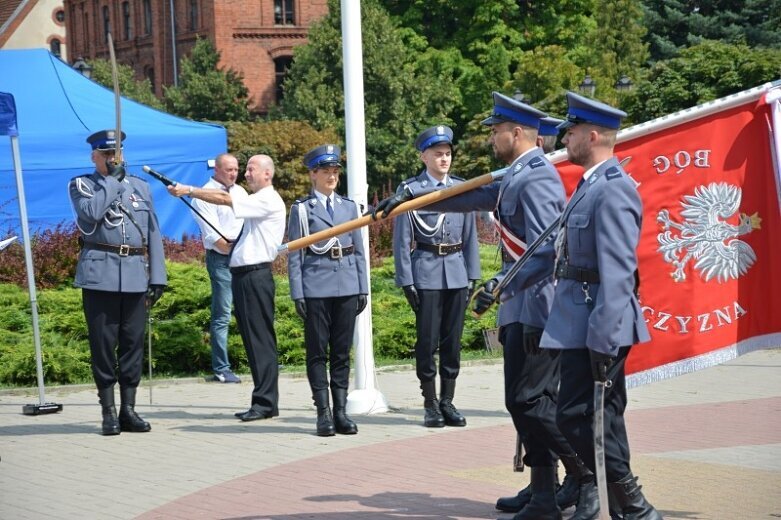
413,148,566,328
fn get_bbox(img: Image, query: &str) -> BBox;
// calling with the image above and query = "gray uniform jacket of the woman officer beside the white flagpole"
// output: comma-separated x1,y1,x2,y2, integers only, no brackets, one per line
287,193,369,300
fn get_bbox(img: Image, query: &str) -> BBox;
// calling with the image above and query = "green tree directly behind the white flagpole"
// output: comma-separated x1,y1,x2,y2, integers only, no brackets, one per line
281,0,453,190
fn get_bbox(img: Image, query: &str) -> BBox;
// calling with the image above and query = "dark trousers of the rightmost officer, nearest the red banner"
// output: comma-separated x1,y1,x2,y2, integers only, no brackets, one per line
556,347,630,482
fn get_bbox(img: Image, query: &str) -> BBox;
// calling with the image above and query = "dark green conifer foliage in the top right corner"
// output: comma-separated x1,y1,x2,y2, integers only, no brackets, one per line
642,0,781,60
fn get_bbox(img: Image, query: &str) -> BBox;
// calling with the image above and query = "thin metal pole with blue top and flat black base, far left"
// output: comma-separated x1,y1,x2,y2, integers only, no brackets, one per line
0,93,62,415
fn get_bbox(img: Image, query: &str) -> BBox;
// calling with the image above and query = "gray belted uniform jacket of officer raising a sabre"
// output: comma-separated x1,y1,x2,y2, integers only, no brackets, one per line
68,172,167,293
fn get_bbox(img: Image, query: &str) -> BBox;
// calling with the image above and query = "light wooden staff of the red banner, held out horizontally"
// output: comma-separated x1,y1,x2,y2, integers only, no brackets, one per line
277,168,506,254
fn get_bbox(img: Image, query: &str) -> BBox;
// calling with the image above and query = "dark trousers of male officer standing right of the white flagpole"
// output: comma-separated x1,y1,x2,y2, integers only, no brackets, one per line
415,287,468,382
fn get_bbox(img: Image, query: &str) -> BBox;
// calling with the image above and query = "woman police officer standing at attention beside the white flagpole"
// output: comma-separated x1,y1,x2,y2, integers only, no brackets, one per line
287,144,369,437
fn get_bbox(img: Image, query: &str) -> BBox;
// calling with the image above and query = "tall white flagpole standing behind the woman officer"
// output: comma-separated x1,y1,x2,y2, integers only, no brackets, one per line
341,0,388,414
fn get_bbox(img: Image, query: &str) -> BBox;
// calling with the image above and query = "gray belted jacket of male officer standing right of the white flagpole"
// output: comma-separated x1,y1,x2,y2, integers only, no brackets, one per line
393,171,480,290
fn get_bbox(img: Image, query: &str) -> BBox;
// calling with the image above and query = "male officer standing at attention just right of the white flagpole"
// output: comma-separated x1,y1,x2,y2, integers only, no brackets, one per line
393,125,480,428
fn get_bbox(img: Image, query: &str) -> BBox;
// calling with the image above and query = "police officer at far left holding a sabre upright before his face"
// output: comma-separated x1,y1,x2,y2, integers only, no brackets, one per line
68,130,167,435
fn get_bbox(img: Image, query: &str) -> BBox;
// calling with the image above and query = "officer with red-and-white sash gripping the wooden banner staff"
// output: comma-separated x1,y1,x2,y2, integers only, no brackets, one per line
377,92,590,520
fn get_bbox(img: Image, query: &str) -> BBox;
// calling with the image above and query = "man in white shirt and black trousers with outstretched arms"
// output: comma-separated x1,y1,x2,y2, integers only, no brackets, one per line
168,155,285,421
